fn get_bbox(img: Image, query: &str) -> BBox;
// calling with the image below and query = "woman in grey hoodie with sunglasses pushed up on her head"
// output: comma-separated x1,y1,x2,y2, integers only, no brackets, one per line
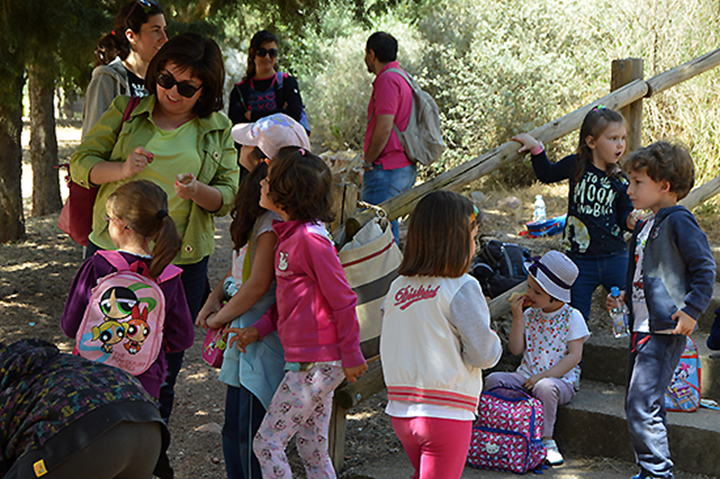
82,0,167,137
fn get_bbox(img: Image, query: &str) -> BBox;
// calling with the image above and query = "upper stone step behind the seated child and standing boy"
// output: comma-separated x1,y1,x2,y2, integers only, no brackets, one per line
582,331,720,401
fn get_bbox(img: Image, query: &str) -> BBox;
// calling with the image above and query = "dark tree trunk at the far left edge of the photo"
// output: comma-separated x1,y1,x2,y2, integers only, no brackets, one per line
0,70,25,244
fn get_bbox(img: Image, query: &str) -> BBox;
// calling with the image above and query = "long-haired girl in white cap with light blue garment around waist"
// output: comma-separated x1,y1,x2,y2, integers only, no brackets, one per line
196,113,310,479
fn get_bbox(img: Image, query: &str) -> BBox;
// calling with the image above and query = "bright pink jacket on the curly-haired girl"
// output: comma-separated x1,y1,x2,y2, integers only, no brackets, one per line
254,221,365,368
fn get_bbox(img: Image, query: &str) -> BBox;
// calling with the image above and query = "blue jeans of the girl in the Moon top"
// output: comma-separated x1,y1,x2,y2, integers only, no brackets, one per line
570,251,628,321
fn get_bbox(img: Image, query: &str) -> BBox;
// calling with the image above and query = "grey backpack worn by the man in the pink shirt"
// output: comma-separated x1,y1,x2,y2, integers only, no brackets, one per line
386,68,445,166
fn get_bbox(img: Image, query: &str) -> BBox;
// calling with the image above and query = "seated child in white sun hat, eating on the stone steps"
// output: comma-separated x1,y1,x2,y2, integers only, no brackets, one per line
485,251,590,465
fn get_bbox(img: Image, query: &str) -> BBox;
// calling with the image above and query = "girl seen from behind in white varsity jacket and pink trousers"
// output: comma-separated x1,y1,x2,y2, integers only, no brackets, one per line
380,191,502,479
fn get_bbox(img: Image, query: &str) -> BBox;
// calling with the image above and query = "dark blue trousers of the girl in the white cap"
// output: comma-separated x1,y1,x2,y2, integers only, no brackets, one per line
223,386,265,479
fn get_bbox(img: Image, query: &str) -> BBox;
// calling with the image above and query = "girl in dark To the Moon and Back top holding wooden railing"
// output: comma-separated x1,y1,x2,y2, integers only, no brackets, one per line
511,106,635,318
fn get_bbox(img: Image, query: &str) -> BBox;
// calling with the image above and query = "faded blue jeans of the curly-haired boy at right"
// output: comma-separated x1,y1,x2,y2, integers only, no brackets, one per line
625,333,685,479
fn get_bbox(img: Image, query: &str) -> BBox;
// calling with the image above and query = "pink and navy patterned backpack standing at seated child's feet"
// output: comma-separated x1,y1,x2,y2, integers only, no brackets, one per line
468,386,547,474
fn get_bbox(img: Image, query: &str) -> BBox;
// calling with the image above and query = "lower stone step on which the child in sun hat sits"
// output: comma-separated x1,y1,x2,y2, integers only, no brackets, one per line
554,380,720,477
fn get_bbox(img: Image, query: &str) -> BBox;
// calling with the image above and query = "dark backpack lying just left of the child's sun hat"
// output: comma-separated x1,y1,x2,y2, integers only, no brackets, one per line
470,240,530,298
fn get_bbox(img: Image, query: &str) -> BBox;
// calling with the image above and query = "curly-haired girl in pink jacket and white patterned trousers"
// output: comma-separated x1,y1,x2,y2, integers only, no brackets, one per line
230,147,367,478
